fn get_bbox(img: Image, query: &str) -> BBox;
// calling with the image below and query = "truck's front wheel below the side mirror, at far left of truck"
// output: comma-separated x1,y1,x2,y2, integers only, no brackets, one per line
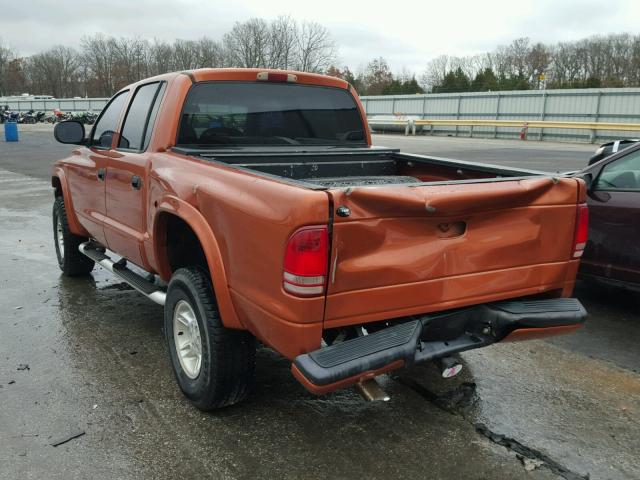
53,197,95,277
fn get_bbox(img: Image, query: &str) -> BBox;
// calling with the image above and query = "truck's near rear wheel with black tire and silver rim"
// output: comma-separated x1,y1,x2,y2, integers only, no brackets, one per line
164,267,256,410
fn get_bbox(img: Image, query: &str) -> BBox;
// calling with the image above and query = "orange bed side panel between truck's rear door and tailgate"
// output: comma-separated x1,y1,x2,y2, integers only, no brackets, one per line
146,153,329,358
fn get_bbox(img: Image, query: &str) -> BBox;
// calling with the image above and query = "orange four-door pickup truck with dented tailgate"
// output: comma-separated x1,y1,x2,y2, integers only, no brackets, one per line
52,69,588,409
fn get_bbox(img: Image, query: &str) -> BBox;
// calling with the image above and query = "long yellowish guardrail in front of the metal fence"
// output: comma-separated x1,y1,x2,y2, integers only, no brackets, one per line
369,118,640,142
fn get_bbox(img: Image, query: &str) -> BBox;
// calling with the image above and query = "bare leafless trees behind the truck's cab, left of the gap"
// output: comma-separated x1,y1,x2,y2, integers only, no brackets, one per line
0,16,336,98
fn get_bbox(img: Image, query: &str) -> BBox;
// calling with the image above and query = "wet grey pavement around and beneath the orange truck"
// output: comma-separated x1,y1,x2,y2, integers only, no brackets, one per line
0,128,640,480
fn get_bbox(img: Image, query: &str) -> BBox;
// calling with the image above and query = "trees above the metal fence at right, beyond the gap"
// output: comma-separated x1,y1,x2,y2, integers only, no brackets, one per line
421,33,640,93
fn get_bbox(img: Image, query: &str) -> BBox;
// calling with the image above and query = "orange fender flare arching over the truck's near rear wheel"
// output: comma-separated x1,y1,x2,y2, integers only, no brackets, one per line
153,196,246,330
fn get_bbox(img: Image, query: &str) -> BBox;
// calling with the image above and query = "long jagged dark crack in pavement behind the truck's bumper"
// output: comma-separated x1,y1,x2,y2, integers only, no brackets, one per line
394,377,590,480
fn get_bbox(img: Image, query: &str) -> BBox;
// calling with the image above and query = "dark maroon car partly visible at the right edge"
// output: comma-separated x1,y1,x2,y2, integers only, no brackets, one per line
579,142,640,289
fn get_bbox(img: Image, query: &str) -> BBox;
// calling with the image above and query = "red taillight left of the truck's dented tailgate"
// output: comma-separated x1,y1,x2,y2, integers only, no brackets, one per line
283,226,329,296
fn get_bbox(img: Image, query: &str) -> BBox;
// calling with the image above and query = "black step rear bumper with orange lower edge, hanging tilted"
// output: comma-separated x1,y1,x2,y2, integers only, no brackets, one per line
292,298,587,394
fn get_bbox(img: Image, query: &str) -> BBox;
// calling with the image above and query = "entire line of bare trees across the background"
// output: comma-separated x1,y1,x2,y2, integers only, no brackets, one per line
0,23,640,98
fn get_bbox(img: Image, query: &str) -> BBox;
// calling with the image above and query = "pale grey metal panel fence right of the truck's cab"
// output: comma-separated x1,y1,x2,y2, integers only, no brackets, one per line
362,88,640,141
